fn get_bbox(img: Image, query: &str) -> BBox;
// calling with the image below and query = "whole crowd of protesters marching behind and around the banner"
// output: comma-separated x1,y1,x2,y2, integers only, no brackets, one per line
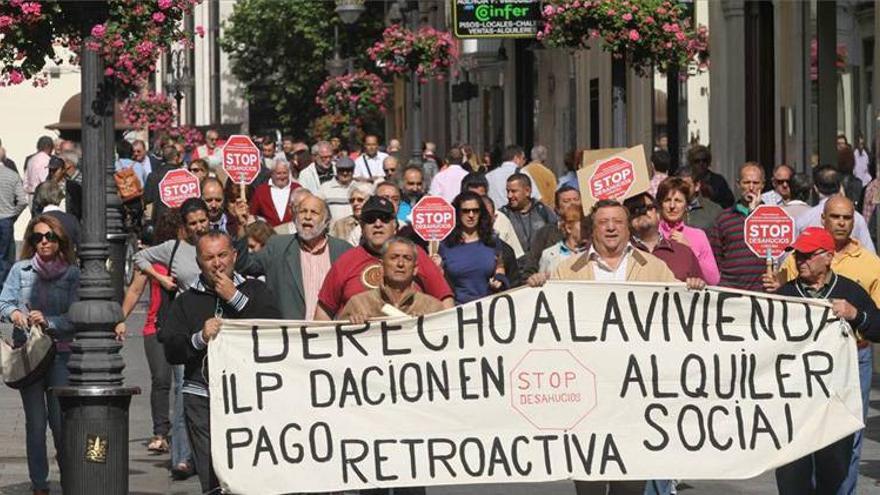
0,130,880,495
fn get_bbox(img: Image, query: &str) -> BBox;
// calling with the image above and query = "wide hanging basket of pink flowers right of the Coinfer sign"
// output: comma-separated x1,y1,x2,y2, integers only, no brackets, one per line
538,0,709,77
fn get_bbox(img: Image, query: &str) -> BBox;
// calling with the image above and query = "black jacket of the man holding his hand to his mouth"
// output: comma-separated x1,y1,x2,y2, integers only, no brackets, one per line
161,274,281,388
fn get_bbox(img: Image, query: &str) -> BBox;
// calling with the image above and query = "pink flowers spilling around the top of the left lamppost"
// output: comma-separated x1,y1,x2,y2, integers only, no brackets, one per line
0,0,204,92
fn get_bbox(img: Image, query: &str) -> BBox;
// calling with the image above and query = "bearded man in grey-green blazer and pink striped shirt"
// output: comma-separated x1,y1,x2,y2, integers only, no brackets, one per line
236,195,351,320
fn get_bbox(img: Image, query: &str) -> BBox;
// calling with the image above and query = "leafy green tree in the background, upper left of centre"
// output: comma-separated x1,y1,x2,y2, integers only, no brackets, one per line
220,0,384,134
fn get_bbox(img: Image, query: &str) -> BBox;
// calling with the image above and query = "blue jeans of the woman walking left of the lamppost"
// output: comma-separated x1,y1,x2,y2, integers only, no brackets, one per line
19,352,70,490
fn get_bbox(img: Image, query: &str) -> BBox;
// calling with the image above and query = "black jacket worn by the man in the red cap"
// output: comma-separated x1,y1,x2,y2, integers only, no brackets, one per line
776,273,880,342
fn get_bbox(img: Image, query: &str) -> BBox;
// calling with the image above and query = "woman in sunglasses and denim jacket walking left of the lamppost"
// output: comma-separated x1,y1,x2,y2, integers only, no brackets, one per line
0,215,79,494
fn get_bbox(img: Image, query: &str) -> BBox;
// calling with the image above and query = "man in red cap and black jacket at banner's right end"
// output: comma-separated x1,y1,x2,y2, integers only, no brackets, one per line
765,227,880,495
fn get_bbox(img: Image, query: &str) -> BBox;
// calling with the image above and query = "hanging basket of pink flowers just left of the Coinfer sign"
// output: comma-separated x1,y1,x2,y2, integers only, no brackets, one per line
367,24,458,84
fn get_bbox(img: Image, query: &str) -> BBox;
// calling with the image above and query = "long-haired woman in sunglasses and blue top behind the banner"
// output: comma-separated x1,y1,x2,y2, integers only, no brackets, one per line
434,191,510,304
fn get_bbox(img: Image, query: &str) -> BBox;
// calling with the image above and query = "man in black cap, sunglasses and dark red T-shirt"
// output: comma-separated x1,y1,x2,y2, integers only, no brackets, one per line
315,196,453,320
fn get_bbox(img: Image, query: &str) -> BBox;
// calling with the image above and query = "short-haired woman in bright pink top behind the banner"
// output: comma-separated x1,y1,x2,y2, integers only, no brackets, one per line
657,177,721,285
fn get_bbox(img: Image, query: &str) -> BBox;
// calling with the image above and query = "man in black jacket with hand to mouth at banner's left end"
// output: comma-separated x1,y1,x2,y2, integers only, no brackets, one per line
162,231,281,493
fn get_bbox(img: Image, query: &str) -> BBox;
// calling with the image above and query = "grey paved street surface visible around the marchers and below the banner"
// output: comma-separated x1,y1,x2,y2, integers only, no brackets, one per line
0,306,880,495
